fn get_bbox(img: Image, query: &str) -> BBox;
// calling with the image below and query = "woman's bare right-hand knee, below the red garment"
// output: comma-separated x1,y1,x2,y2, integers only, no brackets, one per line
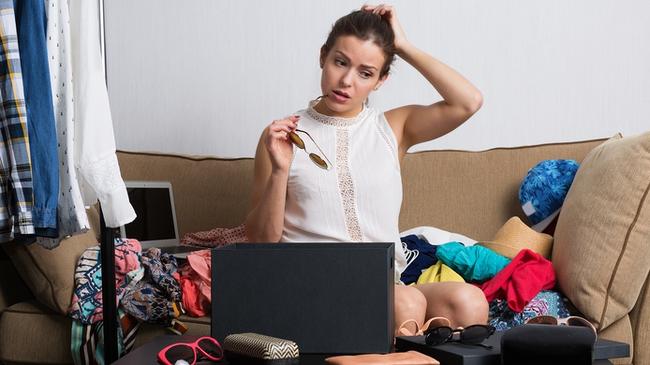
414,282,488,328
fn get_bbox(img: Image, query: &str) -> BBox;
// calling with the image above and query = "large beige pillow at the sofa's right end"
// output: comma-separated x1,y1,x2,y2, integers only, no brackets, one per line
552,133,650,330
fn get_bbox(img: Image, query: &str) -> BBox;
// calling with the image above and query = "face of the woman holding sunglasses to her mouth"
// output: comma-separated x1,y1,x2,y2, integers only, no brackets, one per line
317,35,386,117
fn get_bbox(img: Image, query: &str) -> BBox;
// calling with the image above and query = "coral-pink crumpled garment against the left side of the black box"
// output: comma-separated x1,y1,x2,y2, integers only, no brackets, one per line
180,250,212,317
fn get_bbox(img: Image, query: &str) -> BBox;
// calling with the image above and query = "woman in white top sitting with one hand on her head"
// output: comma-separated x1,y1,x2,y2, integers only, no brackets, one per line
246,5,488,333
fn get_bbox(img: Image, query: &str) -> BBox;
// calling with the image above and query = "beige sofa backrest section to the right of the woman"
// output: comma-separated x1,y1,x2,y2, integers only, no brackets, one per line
399,139,606,240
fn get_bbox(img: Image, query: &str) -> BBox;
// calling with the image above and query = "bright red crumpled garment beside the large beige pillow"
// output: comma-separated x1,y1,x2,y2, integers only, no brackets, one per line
480,249,555,313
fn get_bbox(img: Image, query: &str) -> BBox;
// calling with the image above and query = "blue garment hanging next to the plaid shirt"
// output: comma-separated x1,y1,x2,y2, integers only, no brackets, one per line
14,0,59,237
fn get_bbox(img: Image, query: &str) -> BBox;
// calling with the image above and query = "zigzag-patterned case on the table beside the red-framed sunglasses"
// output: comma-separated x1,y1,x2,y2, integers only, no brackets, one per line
223,333,300,365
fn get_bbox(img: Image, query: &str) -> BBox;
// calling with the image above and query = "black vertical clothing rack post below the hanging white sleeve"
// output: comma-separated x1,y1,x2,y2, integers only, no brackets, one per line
99,206,119,364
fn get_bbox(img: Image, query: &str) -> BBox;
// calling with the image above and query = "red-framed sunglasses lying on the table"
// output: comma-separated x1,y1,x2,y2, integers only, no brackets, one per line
158,336,223,365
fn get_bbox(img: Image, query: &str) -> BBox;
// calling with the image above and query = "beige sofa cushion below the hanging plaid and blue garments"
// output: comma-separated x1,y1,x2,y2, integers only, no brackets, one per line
3,225,97,314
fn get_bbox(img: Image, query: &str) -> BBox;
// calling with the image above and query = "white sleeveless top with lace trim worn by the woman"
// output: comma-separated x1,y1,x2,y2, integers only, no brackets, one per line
281,101,406,281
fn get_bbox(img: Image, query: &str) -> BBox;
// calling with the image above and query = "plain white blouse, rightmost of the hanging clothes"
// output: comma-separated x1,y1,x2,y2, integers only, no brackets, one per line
68,0,136,227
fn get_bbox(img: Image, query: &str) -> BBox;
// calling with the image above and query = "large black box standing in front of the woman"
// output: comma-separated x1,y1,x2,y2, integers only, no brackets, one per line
211,242,395,354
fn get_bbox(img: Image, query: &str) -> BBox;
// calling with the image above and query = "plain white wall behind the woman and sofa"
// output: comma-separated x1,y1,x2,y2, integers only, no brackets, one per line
105,0,650,157
